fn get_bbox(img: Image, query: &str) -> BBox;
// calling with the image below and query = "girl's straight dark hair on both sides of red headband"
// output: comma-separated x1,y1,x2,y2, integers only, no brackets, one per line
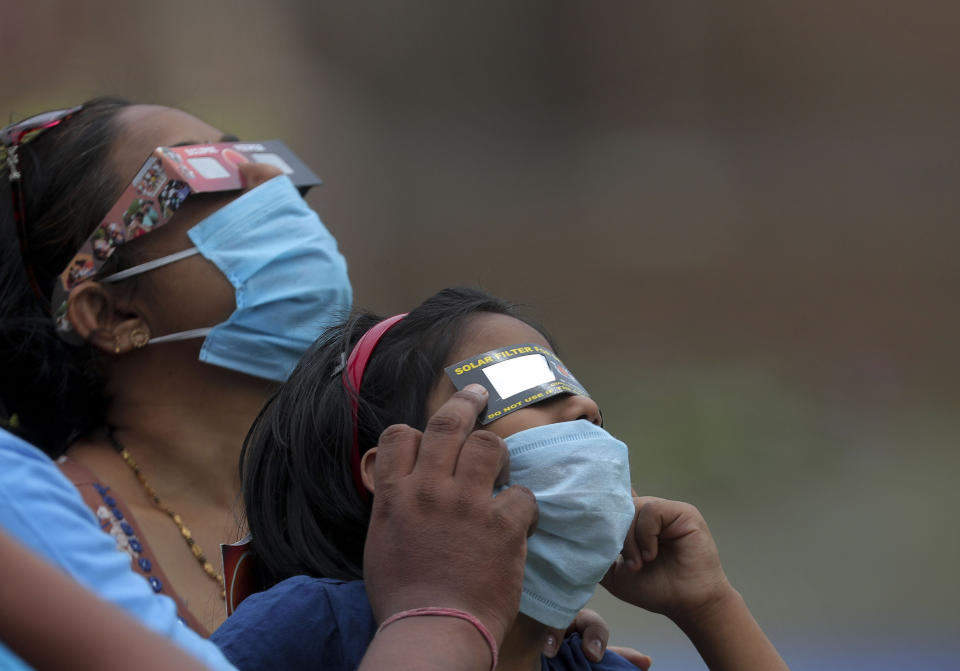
240,289,542,588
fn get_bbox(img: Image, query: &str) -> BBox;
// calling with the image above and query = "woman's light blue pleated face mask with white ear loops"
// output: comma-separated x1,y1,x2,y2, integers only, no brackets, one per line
101,175,353,382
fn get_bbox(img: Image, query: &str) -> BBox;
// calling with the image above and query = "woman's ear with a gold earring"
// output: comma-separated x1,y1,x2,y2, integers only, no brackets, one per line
66,282,150,354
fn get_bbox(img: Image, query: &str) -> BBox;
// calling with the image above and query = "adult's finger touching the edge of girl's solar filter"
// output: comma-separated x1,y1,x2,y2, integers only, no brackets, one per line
417,384,489,475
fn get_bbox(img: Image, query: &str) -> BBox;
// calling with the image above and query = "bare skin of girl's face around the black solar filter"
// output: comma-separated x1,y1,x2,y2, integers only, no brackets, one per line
427,312,601,438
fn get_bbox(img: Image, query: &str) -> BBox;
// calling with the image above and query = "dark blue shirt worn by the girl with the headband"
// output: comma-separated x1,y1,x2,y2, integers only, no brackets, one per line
210,576,636,671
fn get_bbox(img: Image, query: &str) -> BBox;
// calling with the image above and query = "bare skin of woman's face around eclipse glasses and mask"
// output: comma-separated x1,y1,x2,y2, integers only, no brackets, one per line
110,105,281,348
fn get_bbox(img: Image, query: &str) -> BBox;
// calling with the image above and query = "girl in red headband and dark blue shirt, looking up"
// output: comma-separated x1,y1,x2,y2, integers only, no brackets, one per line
213,289,786,670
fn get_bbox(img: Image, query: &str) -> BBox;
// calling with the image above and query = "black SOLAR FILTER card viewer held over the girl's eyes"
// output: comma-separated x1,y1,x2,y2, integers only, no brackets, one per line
444,343,590,425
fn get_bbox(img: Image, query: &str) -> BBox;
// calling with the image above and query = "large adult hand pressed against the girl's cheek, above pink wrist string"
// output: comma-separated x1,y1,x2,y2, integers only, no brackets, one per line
363,385,537,642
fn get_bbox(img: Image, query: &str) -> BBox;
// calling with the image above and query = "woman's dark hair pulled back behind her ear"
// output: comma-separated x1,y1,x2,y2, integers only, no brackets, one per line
0,98,135,456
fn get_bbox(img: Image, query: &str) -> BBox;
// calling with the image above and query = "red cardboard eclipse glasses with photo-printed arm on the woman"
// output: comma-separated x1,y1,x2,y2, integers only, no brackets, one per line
50,140,321,335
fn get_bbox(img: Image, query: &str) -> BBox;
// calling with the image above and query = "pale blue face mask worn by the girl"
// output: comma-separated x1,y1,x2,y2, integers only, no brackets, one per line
506,419,634,629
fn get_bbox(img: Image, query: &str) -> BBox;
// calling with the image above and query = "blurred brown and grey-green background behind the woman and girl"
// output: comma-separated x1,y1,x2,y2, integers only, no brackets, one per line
0,0,960,669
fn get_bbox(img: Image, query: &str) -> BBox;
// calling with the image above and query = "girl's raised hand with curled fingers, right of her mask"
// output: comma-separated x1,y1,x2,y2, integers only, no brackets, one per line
600,492,733,622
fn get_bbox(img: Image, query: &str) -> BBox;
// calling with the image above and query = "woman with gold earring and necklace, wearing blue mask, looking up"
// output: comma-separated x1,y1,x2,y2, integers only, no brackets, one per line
0,99,351,633
